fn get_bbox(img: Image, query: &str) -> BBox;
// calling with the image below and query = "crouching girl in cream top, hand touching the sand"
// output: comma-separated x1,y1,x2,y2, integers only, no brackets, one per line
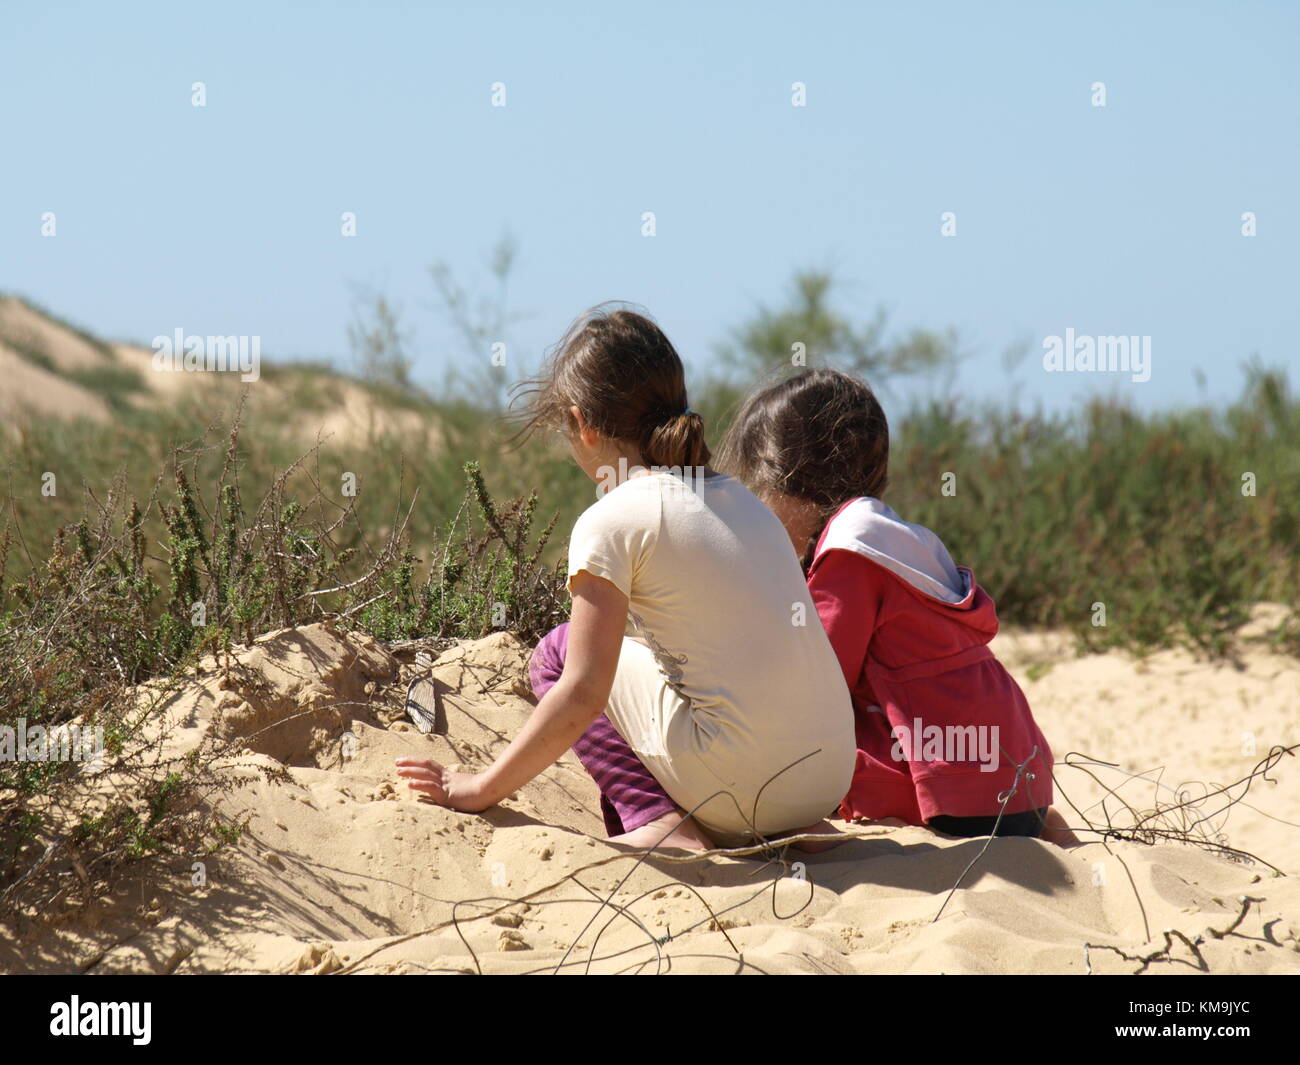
398,307,854,848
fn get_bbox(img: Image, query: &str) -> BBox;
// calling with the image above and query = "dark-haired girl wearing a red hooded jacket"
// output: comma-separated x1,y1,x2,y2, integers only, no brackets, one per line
719,369,1075,844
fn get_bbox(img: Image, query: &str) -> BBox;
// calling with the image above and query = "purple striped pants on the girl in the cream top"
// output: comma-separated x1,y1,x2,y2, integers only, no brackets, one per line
528,622,677,836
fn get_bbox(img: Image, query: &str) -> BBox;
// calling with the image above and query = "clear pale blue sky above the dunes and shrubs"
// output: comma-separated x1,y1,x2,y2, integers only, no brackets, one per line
0,0,1300,408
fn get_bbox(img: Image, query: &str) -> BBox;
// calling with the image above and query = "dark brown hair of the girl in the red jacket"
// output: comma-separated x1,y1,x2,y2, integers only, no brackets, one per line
718,368,889,523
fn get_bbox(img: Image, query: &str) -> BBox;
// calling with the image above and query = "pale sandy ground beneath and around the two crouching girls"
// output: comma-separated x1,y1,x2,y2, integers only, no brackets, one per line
0,611,1300,974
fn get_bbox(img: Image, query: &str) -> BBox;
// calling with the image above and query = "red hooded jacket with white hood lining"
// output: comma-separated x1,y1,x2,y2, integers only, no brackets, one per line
809,497,1052,824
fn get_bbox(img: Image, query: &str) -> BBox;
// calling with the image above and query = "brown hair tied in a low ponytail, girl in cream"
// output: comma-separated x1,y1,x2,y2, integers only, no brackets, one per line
515,303,710,467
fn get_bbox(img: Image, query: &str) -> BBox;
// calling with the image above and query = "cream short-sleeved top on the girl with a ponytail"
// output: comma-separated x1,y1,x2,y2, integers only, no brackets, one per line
568,472,855,822
